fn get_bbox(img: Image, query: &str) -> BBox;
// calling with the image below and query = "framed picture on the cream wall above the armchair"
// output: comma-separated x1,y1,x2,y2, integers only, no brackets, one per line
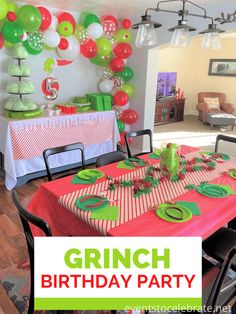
208,59,236,77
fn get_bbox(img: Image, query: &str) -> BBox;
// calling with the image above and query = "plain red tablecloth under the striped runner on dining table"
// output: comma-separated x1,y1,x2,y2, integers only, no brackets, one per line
28,146,236,238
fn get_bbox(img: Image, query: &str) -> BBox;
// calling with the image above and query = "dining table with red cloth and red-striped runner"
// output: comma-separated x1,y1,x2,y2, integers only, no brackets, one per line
27,145,236,239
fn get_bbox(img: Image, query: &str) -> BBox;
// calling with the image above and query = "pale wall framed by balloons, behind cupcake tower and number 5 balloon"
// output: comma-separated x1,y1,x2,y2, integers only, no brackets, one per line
0,48,99,111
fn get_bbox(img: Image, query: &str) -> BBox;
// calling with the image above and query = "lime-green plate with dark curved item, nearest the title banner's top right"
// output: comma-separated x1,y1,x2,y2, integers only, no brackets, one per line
156,204,193,223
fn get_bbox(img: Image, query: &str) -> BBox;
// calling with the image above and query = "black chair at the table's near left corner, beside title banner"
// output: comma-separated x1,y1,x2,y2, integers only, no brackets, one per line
12,191,52,314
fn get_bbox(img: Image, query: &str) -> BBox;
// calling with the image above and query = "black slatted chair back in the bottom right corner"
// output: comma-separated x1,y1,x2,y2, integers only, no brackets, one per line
204,247,236,314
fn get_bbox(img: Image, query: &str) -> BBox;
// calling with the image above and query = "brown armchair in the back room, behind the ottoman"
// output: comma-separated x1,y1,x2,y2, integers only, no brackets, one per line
196,92,235,123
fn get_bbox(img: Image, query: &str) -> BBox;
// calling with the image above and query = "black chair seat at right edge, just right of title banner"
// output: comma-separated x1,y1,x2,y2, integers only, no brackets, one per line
202,227,236,271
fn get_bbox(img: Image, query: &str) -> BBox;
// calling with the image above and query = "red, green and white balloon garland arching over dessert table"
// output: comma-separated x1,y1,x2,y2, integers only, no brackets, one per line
0,0,138,145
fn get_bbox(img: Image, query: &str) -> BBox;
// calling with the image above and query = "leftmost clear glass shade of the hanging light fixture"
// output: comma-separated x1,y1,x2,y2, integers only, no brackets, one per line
135,24,157,48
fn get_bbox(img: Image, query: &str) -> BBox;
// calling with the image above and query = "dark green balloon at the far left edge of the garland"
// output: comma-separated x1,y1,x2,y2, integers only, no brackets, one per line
2,21,24,44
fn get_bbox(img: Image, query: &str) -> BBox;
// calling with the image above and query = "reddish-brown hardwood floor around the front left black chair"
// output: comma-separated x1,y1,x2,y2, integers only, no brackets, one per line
0,178,47,314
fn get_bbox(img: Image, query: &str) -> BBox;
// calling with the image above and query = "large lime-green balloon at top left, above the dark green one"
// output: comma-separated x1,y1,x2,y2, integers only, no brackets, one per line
17,5,42,32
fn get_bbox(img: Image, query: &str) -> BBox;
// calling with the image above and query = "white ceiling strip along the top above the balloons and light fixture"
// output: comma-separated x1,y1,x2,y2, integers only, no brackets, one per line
18,0,227,17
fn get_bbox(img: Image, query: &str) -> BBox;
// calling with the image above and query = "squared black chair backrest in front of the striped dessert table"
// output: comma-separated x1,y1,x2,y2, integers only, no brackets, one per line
43,142,84,181
